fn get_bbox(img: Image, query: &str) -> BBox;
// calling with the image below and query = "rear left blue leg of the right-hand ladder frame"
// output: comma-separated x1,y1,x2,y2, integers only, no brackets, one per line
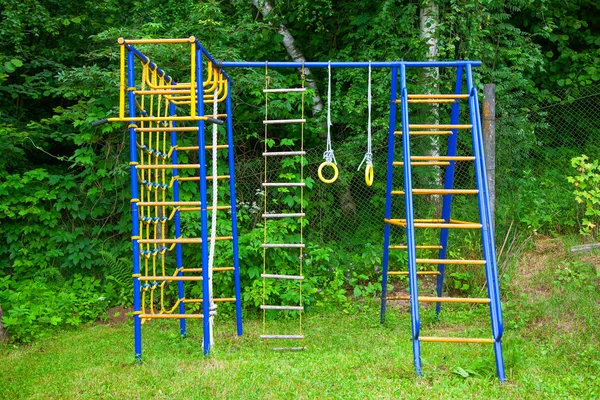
379,66,398,323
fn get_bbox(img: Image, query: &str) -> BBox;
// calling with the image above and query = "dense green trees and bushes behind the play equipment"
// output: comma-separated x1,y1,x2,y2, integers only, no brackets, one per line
0,0,600,342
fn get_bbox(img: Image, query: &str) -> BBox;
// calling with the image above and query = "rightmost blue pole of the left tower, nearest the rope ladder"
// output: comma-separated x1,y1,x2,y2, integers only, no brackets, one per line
226,80,242,336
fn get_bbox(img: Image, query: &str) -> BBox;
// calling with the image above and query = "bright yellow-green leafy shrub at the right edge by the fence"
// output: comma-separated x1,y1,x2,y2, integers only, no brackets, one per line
567,155,600,238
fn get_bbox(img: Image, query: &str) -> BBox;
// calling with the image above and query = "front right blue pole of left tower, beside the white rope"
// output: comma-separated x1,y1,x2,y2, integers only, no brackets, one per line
196,48,216,355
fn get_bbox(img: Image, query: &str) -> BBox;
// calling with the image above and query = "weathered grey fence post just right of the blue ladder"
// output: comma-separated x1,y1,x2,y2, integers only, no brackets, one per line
482,83,496,227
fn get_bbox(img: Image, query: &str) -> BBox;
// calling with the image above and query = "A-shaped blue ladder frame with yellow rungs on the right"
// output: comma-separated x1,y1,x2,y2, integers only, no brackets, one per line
381,61,505,381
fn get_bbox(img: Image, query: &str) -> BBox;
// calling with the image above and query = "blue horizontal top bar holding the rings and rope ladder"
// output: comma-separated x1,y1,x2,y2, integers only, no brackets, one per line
220,61,481,68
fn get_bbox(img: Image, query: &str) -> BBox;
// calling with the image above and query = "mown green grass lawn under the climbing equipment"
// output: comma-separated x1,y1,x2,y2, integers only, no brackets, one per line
0,236,600,399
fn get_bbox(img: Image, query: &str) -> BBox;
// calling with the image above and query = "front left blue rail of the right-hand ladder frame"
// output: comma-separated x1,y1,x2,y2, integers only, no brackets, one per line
400,65,421,375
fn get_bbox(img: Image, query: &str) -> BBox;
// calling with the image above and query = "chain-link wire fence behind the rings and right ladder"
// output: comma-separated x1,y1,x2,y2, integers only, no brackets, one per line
231,85,600,248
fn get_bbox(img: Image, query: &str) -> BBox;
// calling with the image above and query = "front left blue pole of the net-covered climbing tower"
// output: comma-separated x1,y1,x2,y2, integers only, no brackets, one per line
127,48,142,362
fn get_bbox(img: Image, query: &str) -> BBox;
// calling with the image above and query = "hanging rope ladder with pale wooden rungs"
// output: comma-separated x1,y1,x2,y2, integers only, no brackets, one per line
260,66,306,351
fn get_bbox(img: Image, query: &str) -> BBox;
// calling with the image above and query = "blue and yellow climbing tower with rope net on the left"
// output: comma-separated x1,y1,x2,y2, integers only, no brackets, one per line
105,37,242,360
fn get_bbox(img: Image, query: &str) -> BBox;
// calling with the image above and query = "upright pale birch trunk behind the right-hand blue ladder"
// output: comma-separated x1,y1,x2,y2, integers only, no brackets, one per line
419,0,443,213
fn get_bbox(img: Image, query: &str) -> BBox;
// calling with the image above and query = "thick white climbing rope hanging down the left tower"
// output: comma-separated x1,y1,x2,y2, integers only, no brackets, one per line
208,88,218,347
